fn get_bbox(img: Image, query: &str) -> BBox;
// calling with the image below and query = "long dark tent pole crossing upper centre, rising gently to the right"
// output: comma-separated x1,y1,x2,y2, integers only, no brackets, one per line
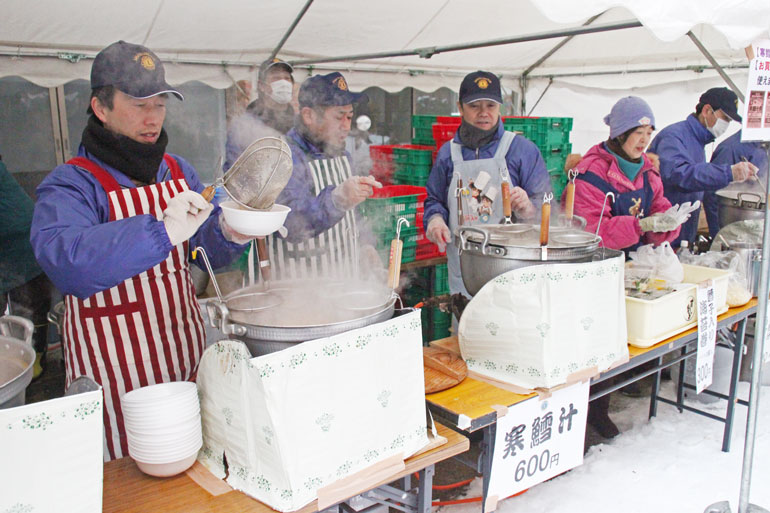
289,20,642,66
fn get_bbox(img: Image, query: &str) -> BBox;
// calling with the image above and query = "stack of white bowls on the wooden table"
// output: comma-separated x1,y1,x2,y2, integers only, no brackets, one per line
120,381,203,477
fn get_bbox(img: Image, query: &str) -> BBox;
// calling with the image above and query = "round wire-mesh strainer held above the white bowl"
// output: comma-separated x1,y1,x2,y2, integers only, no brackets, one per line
218,137,292,210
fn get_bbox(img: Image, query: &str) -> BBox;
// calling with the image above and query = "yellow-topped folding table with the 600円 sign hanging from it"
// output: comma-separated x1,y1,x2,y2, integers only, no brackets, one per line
426,299,757,510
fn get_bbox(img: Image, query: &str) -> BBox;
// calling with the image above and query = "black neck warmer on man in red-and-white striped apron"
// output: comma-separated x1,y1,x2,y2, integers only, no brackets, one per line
82,115,168,184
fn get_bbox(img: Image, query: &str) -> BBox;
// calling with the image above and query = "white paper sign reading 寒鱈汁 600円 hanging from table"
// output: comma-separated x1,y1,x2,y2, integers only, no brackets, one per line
485,381,589,511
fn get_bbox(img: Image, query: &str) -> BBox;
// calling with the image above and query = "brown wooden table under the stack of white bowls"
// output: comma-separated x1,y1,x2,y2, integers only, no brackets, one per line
103,423,469,513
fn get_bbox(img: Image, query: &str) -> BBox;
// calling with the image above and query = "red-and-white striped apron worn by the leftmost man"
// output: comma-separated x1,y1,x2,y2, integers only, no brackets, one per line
63,155,205,459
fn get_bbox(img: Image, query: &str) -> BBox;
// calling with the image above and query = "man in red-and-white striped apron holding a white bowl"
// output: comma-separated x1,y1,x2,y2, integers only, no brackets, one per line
31,41,250,460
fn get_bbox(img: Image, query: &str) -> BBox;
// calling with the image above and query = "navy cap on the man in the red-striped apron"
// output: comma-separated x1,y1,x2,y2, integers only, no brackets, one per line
91,41,184,100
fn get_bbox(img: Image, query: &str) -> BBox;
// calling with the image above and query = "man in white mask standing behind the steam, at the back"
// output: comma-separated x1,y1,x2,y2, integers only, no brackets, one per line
224,57,294,170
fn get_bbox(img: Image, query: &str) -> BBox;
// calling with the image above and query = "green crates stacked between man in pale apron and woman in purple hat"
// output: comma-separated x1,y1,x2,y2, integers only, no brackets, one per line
503,117,572,201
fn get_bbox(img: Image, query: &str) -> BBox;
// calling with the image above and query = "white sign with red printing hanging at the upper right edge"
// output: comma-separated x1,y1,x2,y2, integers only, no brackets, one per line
741,40,770,141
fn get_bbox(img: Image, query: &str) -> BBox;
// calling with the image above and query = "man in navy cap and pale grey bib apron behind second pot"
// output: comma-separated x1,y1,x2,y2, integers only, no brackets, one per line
424,71,551,297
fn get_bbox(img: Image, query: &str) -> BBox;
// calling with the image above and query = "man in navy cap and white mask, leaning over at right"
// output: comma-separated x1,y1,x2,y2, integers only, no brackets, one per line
649,87,757,247
